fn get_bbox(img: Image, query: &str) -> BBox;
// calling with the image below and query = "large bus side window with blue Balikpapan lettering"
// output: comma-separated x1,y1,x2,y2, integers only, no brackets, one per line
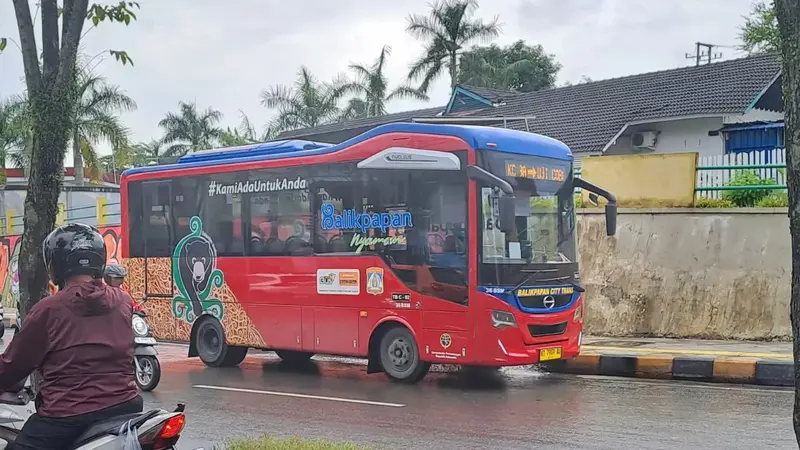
314,152,468,304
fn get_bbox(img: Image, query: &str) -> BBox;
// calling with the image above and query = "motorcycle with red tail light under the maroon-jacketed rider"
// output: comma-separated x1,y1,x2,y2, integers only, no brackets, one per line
0,386,186,450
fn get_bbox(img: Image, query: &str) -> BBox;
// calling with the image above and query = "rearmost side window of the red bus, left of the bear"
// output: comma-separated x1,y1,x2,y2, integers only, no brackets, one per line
142,181,173,258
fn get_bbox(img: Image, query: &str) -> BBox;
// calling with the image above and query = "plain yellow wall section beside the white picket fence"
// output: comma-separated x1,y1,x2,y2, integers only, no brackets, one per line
581,153,697,207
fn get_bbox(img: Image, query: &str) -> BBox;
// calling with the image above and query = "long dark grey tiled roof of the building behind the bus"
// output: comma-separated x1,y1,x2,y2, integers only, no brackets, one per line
459,55,780,153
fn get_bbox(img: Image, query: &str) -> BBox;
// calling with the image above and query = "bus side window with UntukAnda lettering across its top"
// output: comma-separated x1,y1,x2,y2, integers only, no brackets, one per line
248,171,313,256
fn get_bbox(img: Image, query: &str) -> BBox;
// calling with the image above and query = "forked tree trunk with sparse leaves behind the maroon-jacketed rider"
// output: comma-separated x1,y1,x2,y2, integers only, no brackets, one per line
0,0,139,324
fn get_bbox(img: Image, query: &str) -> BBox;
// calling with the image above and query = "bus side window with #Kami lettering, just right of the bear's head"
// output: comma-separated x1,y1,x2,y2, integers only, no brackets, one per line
199,174,244,256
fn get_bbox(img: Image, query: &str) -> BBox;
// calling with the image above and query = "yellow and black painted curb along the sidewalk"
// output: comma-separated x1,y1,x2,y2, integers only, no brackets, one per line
542,353,794,386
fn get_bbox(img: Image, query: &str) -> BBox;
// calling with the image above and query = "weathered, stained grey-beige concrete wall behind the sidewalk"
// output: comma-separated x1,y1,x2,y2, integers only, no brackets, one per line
577,208,791,339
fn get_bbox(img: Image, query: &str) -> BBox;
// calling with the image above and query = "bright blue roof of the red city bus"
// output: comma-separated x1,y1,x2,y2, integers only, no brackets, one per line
123,123,572,175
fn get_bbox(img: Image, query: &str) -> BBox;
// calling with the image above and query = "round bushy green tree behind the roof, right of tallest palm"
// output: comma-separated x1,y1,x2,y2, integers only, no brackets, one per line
457,40,561,92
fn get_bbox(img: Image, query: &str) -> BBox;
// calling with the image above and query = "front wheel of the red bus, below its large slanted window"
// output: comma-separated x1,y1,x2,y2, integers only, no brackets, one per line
380,327,431,384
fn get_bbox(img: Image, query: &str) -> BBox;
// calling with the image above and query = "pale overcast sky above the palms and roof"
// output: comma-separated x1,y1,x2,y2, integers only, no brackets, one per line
0,0,751,156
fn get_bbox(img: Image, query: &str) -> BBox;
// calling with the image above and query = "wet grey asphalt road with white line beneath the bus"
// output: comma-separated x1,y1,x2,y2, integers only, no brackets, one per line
145,357,797,450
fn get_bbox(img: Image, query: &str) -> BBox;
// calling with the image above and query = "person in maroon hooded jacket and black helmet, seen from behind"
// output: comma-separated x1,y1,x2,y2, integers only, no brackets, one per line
0,223,143,450
